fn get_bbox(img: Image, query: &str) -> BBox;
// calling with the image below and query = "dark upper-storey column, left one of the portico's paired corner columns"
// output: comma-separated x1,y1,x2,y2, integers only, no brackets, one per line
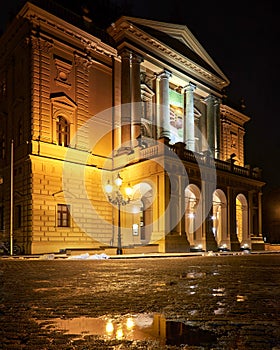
121,50,131,148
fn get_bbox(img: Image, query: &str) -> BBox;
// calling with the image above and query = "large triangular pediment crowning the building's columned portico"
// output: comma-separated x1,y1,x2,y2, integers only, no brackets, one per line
108,16,229,88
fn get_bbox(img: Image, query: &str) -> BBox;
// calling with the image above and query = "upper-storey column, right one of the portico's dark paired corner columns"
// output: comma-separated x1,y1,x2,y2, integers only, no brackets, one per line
131,53,143,146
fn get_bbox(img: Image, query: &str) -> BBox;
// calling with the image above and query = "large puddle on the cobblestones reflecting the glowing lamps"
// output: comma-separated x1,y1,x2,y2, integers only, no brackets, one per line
38,314,217,346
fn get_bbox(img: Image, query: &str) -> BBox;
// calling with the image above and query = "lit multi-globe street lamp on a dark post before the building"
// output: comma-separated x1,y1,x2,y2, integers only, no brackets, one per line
105,173,132,255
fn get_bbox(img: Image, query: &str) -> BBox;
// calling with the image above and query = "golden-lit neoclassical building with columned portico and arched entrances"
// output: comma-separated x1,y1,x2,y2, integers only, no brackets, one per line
0,3,264,254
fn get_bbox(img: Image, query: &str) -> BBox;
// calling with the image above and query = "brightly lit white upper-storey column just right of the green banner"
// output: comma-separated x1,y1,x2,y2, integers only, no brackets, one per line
184,83,196,151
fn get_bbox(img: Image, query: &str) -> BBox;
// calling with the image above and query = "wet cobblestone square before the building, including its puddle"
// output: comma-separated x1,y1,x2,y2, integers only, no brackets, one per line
0,254,280,350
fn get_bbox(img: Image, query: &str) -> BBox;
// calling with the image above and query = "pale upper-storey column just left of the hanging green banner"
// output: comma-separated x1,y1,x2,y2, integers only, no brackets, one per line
158,70,171,140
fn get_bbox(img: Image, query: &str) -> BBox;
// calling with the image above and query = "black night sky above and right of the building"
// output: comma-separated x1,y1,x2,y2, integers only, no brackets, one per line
0,0,280,191
